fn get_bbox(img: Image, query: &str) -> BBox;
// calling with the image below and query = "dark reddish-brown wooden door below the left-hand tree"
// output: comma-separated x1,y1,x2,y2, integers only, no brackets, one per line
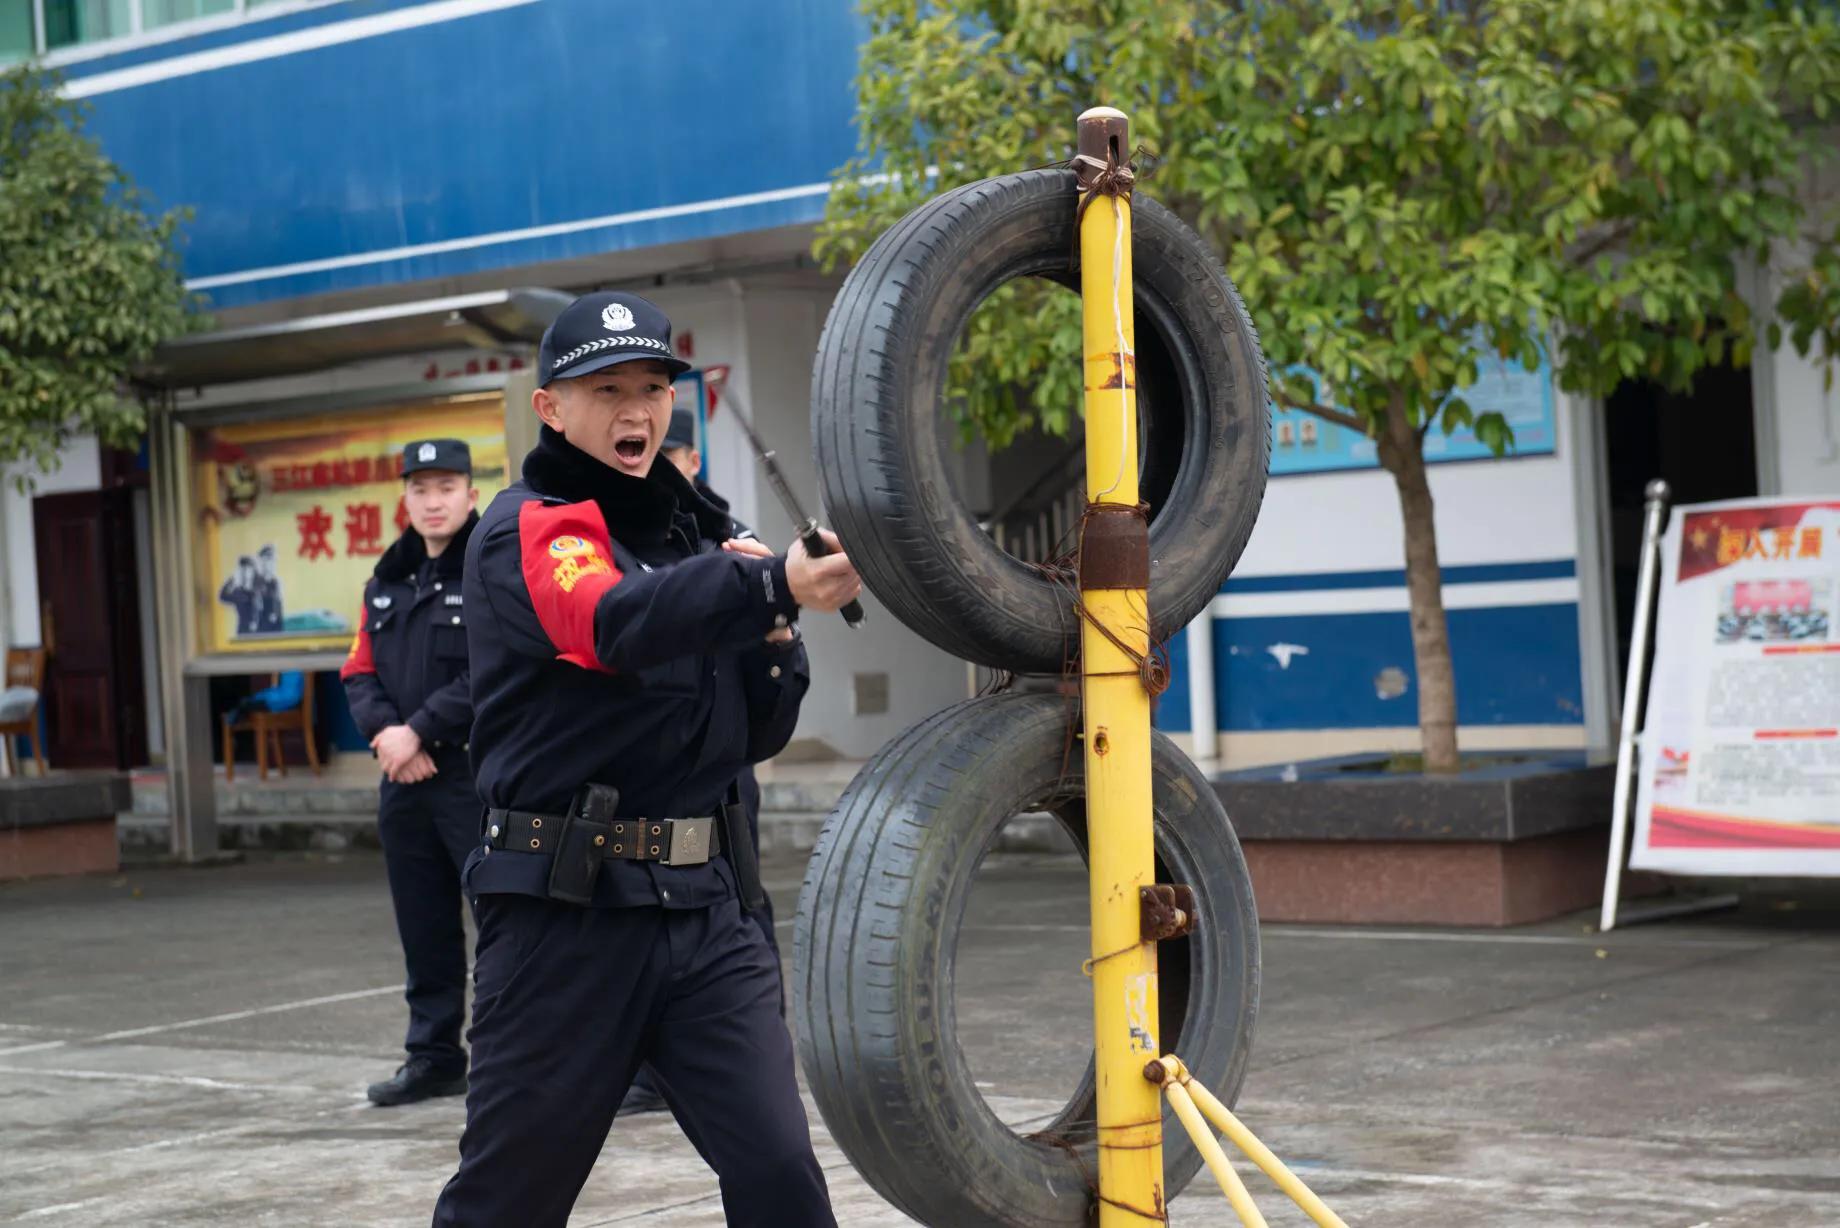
33,490,147,768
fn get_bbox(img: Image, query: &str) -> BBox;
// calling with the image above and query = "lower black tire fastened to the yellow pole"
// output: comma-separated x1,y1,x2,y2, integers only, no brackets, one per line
793,694,1259,1228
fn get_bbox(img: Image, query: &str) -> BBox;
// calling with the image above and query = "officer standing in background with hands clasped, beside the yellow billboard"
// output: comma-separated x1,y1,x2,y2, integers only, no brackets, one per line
339,440,478,1105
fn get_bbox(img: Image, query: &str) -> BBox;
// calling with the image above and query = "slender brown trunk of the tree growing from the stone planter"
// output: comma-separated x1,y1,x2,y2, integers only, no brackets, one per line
1378,394,1457,771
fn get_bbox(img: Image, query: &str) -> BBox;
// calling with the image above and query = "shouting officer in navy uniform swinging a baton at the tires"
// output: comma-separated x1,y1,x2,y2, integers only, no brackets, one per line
434,293,861,1228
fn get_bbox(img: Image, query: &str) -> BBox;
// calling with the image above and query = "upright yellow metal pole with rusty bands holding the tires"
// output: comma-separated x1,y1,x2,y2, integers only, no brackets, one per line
1078,107,1167,1228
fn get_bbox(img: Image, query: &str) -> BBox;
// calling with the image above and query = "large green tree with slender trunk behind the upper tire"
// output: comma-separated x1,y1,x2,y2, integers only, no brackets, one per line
817,0,1840,771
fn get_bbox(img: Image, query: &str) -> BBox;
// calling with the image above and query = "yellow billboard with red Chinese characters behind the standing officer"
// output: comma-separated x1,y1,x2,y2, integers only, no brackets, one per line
191,392,506,652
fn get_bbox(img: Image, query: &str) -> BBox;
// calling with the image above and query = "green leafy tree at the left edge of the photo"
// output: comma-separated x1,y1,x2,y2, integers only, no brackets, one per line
0,66,199,469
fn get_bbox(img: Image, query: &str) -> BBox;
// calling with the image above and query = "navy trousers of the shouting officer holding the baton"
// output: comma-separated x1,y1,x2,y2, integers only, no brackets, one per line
434,895,837,1228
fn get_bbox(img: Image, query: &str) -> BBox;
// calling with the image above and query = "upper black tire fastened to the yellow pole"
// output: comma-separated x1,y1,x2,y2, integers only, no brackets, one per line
811,169,1271,674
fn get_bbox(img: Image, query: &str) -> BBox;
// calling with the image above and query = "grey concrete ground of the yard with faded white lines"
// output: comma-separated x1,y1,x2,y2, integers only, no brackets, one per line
0,851,1840,1228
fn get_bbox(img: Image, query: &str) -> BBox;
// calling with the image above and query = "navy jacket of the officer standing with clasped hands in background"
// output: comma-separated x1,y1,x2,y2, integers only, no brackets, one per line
339,514,478,751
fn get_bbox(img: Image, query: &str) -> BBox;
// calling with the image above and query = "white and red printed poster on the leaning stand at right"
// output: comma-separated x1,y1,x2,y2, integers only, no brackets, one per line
1630,499,1840,876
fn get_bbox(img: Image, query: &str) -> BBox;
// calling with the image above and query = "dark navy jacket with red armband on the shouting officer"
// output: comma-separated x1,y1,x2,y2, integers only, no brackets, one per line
466,427,810,908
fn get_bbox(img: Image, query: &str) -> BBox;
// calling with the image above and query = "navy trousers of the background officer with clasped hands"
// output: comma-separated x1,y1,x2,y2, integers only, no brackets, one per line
377,746,480,1072
